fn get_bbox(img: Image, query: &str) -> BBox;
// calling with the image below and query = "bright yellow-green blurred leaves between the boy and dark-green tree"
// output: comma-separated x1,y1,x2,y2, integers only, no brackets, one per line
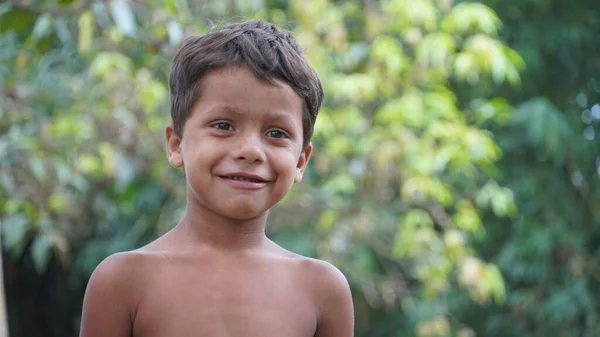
282,1,521,336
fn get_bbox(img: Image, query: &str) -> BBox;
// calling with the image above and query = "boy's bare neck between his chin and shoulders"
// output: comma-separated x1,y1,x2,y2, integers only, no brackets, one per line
177,197,268,251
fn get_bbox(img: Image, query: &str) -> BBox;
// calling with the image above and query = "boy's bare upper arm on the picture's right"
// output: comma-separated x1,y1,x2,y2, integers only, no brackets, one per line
315,262,354,337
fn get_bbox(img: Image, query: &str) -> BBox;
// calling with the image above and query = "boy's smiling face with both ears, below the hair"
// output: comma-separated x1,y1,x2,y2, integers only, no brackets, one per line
167,67,312,219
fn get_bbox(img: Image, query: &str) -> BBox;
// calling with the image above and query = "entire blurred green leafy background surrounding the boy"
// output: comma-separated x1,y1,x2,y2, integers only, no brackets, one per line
0,0,600,337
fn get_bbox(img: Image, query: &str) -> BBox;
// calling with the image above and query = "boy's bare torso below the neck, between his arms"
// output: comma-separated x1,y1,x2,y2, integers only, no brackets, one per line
132,240,318,337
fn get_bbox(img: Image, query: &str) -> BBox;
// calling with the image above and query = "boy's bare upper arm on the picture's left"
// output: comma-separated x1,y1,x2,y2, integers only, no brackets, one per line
79,253,141,337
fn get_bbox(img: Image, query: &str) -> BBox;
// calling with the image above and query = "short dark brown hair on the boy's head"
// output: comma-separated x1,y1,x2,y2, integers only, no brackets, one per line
169,20,323,146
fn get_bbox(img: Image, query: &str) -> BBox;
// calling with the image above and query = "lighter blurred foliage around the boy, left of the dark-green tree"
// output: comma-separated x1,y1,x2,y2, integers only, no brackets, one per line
0,0,523,337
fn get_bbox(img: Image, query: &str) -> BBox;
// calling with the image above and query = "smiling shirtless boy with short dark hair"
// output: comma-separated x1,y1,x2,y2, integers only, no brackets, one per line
81,21,354,337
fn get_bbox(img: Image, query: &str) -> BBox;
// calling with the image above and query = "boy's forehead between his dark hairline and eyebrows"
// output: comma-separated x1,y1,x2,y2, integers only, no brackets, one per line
196,66,303,119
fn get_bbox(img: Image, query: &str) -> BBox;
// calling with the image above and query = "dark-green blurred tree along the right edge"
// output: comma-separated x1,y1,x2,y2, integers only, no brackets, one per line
452,0,600,337
